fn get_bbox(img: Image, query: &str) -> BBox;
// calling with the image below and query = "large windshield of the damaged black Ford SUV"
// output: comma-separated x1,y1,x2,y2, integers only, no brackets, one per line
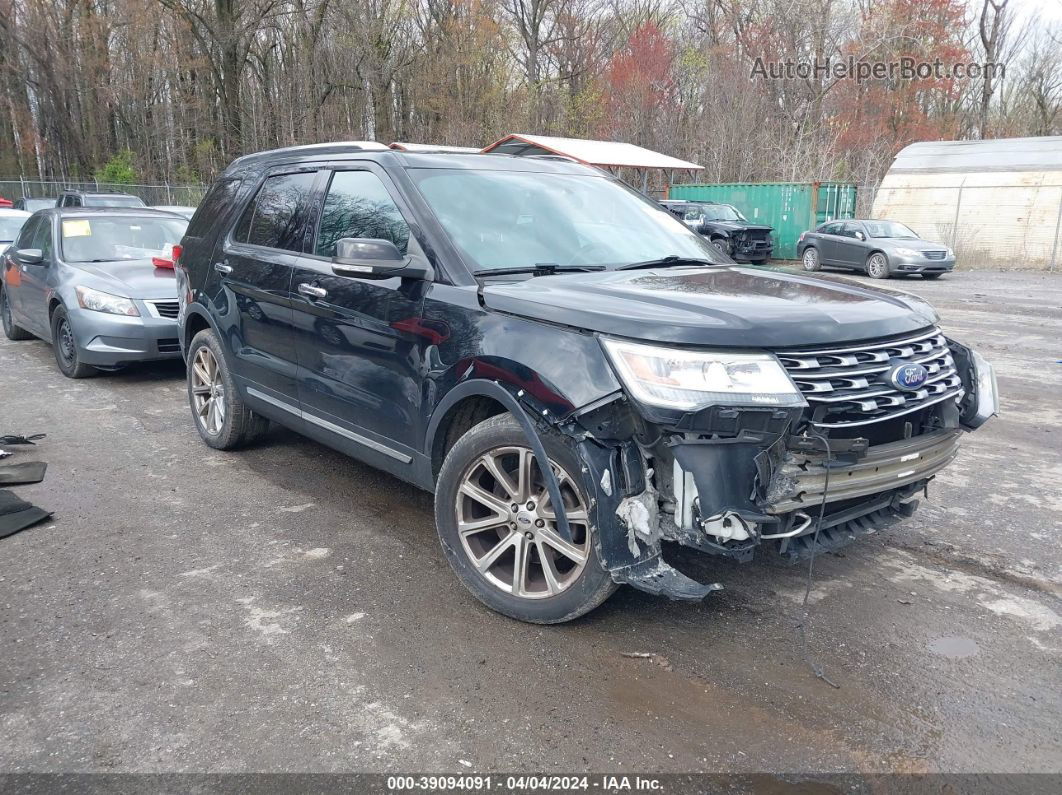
409,169,721,271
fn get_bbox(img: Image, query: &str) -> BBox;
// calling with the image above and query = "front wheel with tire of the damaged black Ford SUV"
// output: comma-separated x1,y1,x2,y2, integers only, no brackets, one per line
435,414,617,624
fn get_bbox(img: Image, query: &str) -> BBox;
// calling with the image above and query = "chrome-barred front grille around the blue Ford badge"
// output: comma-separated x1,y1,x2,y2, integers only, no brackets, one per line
777,329,963,428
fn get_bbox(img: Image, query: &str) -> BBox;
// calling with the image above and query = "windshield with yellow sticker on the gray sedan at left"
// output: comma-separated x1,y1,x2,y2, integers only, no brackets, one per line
61,215,188,262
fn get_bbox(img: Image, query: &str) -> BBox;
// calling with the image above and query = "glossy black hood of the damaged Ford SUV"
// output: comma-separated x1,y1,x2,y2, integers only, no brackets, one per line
482,266,937,348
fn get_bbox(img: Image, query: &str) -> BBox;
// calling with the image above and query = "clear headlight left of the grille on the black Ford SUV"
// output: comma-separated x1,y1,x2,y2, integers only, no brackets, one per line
602,340,805,411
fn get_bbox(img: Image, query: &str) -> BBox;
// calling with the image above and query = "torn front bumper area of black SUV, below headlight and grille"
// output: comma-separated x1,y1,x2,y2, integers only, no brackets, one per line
567,335,998,600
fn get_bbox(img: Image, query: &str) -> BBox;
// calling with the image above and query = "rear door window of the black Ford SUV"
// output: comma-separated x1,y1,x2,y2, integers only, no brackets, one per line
235,171,316,252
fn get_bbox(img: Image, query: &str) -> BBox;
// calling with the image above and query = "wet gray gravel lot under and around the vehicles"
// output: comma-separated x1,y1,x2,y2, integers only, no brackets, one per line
0,272,1062,773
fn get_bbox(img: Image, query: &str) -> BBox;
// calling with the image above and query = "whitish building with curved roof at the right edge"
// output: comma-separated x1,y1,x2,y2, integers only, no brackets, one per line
873,136,1062,269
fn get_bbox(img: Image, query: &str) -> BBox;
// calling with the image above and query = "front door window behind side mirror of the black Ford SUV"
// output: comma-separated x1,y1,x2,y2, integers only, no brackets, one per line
313,171,409,257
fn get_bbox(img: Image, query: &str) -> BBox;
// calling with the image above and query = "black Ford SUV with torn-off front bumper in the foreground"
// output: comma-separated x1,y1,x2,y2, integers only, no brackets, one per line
176,143,996,623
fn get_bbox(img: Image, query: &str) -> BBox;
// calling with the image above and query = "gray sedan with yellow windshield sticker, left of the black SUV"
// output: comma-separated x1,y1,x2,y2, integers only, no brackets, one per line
0,207,188,378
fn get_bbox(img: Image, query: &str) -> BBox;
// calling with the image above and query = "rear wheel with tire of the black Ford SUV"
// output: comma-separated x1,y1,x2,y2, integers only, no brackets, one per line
187,329,269,450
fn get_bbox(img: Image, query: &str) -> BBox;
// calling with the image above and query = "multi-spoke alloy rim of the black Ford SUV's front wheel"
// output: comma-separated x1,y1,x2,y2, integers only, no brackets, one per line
455,447,590,599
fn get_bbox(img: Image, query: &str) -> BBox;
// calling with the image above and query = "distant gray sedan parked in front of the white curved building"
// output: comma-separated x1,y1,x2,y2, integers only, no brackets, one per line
797,220,955,279
